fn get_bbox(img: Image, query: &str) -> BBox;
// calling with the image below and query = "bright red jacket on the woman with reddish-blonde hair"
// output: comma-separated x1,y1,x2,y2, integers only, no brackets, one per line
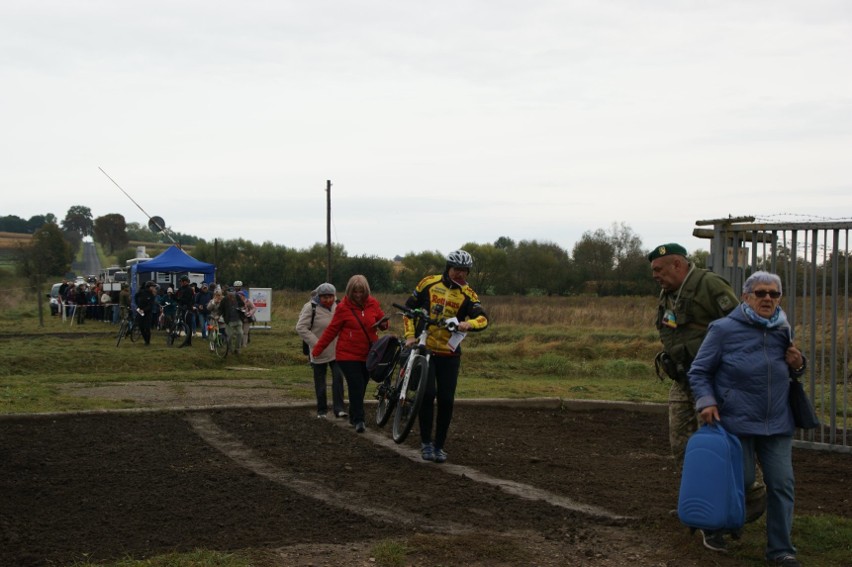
311,295,388,362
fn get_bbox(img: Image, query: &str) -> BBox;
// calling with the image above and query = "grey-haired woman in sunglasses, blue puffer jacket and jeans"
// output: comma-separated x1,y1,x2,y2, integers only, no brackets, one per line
689,272,805,566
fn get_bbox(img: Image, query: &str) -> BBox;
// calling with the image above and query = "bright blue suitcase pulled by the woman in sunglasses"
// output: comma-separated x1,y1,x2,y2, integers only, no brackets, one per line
677,423,745,532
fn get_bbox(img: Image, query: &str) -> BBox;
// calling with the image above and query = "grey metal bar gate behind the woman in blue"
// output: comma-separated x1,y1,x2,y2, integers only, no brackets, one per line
693,217,852,453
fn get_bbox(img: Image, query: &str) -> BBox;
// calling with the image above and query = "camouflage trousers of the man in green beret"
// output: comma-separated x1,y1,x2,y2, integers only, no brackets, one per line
669,381,766,522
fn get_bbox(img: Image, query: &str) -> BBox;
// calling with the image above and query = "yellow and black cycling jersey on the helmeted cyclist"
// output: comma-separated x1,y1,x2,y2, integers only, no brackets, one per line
403,274,488,356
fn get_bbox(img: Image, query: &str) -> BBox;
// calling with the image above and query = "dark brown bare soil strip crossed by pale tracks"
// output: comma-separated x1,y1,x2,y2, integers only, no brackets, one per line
0,398,852,566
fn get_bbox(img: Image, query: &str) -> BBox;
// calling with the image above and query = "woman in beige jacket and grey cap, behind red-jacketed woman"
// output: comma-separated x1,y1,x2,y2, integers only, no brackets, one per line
296,283,348,418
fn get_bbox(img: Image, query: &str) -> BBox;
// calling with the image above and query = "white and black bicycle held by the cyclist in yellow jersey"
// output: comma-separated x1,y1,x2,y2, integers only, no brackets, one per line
376,303,458,443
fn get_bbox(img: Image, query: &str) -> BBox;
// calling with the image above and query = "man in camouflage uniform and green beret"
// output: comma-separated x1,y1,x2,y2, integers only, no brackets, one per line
648,242,766,551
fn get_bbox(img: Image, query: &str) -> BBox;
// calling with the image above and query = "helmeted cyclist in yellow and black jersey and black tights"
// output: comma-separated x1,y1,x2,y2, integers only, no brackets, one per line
403,250,488,463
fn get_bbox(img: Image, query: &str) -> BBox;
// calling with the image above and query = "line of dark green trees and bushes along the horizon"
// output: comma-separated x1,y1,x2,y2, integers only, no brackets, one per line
5,210,658,295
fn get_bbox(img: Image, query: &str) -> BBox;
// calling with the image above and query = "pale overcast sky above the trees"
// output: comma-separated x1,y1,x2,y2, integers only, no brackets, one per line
0,0,852,258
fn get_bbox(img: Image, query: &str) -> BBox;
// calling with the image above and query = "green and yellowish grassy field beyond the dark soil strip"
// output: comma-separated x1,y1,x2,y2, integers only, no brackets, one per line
0,277,852,567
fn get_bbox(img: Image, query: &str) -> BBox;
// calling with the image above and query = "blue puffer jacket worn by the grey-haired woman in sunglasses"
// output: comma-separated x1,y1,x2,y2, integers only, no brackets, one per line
689,307,795,436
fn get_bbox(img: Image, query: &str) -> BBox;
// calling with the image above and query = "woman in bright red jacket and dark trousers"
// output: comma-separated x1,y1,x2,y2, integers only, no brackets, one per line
311,275,388,433
